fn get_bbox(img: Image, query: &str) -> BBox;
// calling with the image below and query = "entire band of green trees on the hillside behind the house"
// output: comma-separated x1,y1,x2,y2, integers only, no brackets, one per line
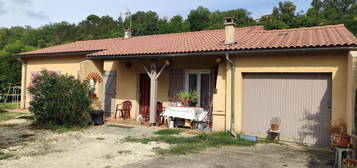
0,0,357,94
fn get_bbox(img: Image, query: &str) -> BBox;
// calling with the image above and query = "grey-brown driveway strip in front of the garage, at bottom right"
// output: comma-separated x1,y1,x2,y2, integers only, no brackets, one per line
124,144,334,168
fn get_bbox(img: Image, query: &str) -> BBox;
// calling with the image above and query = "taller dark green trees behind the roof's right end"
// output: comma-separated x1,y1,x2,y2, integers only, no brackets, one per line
259,0,357,35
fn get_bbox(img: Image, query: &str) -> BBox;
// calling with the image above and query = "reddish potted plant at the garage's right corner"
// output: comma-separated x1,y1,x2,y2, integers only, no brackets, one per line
331,120,351,147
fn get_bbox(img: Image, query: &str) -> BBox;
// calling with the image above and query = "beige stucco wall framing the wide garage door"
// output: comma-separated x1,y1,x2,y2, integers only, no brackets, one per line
226,52,352,132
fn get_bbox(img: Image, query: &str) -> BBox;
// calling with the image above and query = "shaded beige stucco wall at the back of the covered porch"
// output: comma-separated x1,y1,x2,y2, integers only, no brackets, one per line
104,57,216,118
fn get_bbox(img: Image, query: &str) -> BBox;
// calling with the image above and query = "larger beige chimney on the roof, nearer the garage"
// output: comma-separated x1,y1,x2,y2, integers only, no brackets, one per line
224,17,236,45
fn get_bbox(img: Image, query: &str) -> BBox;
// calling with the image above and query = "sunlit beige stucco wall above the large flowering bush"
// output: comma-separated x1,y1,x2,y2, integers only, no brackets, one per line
21,55,85,108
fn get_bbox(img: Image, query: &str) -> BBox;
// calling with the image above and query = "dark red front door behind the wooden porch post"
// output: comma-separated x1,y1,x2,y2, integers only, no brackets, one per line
139,73,150,120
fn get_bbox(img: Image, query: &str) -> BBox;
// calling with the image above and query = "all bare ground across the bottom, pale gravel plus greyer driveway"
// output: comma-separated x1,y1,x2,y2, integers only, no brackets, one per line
0,113,332,168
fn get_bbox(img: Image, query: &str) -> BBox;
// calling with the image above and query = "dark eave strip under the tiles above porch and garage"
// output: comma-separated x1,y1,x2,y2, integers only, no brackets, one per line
87,46,357,60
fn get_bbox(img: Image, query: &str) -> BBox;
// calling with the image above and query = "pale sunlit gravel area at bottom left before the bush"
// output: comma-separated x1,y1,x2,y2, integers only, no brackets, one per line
0,125,169,168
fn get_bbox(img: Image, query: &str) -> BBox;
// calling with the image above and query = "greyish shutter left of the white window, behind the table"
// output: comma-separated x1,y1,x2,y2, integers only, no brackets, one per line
168,69,183,101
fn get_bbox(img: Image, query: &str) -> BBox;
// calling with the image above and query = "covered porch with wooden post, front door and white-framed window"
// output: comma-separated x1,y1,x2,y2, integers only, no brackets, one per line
99,56,225,125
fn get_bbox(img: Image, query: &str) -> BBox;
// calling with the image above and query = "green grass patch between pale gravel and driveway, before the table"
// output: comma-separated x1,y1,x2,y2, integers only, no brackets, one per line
123,132,255,155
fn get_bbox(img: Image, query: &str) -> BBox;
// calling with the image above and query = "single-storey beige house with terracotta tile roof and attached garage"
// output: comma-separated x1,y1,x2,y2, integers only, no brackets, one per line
16,18,357,145
